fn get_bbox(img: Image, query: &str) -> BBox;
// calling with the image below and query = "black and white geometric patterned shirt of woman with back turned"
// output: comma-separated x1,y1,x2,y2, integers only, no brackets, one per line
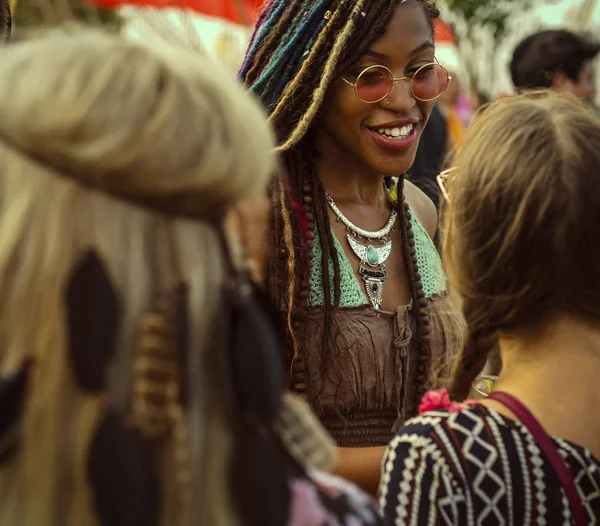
379,405,600,526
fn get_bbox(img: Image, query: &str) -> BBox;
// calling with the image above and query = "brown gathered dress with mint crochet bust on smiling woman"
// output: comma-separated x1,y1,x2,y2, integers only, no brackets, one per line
293,212,464,447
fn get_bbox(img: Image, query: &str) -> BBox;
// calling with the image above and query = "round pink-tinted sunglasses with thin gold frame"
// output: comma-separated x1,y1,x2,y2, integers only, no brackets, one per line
342,62,452,104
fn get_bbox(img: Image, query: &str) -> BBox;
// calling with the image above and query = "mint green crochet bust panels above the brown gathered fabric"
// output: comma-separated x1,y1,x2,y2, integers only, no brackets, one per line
308,212,447,307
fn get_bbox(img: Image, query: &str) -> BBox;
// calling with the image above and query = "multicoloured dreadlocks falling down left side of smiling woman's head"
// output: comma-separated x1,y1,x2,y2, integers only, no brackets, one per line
239,0,439,412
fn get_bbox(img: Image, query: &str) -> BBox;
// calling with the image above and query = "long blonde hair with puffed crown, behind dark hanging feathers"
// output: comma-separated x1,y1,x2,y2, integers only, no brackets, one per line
0,29,274,526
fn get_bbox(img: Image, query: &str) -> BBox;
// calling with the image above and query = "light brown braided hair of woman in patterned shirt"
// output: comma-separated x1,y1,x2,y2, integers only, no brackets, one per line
444,93,600,399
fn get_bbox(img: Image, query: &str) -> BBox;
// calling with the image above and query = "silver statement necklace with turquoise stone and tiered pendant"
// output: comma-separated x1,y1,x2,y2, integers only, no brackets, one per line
325,193,398,310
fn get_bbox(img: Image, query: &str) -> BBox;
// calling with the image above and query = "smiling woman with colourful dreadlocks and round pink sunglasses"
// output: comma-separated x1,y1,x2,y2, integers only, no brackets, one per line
240,0,462,496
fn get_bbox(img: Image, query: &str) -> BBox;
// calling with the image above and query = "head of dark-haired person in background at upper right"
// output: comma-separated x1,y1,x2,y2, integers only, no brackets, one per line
510,30,600,105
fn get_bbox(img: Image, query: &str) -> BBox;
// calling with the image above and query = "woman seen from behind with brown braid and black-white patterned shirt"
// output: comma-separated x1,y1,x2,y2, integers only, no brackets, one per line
380,93,600,526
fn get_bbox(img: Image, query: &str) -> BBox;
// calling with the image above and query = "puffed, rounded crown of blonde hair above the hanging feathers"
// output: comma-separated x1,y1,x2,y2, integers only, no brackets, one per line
0,29,273,217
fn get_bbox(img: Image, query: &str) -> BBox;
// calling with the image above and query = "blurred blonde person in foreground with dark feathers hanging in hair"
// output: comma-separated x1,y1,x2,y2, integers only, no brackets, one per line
0,29,378,526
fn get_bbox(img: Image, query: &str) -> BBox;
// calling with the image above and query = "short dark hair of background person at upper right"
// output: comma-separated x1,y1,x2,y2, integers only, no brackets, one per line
510,30,600,90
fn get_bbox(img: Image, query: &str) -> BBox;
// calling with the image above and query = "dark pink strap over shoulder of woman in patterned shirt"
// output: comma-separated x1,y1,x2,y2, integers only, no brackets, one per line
488,391,588,526
